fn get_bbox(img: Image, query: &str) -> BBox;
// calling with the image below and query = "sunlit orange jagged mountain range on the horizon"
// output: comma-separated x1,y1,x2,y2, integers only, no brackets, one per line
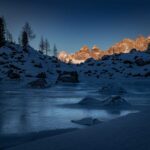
58,36,150,64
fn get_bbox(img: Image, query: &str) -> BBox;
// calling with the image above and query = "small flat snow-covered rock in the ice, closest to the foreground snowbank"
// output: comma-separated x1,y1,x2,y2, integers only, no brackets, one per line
71,117,101,126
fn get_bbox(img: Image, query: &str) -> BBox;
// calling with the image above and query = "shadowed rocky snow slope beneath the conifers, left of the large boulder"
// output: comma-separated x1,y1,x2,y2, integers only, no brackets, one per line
0,44,71,84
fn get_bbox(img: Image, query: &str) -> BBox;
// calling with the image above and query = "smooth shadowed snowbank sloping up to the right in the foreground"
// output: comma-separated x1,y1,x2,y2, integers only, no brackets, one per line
6,105,150,150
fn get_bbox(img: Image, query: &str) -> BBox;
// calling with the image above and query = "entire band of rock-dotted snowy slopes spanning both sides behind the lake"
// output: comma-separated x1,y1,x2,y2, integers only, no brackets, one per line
0,43,150,85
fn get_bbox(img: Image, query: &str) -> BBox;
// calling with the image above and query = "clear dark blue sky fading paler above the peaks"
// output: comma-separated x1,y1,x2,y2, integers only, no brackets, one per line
0,0,150,52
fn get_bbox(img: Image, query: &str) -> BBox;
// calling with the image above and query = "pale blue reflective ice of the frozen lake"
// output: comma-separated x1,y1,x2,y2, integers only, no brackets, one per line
0,81,150,135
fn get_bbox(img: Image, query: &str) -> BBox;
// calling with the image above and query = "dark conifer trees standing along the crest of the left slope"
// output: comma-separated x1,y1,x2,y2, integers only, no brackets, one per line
0,17,58,56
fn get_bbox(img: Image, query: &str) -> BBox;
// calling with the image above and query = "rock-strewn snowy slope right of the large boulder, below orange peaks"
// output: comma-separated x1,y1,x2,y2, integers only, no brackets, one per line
78,51,150,80
